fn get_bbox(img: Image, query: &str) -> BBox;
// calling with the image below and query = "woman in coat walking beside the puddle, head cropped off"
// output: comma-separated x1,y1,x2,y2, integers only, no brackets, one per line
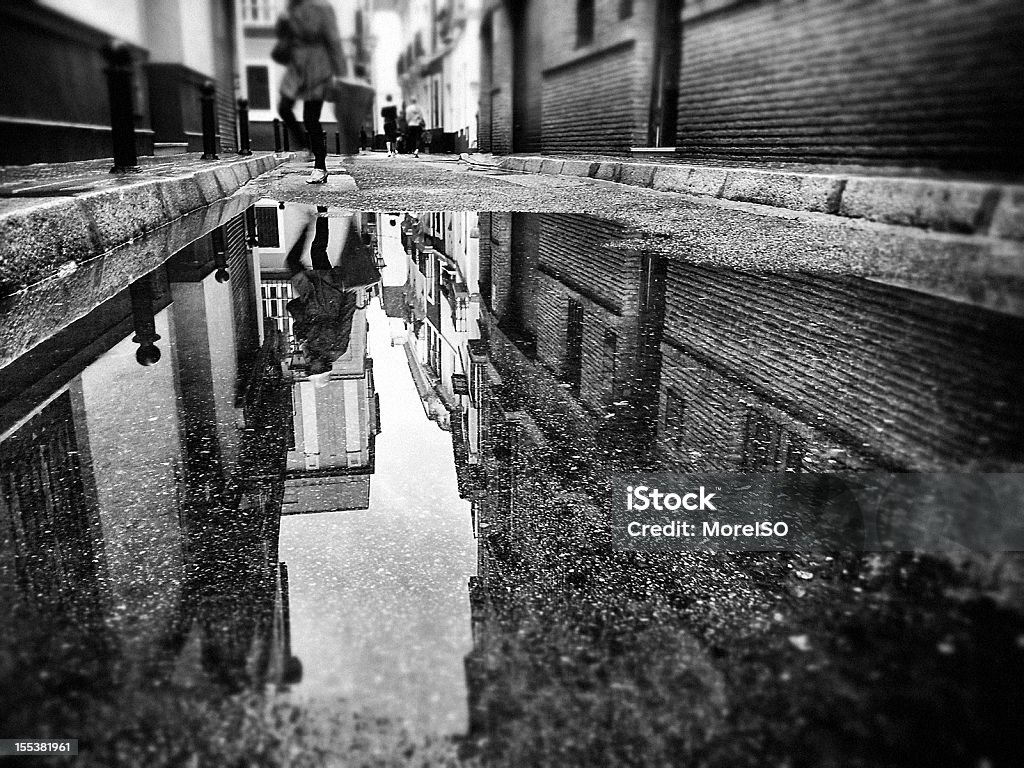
278,0,347,184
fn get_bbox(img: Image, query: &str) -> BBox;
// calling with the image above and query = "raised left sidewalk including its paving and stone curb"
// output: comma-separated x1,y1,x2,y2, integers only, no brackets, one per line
0,153,288,296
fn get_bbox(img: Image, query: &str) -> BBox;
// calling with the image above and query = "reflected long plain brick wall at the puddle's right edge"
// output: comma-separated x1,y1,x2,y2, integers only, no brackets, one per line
663,263,1024,470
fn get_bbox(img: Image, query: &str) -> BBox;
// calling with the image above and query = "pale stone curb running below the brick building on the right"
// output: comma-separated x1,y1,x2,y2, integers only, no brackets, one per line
497,156,1024,240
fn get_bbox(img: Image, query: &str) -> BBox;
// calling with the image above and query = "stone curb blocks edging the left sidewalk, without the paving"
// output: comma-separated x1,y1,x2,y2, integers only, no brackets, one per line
0,154,288,296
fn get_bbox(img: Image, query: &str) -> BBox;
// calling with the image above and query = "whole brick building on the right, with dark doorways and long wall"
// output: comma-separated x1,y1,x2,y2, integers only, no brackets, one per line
480,0,1024,172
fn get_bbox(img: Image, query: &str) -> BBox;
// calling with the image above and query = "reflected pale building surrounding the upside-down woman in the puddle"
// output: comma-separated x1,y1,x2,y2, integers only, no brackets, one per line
255,201,381,514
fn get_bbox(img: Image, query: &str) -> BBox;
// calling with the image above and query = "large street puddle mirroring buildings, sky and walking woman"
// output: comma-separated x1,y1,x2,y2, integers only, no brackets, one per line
0,201,1024,765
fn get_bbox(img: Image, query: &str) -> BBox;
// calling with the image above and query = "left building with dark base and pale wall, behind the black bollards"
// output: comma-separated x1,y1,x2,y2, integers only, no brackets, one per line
0,0,238,165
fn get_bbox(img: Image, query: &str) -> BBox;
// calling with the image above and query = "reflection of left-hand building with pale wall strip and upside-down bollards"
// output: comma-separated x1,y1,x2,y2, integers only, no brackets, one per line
0,210,297,704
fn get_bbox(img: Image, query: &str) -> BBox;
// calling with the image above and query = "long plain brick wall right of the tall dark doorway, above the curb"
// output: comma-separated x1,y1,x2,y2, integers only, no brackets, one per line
678,0,1024,171
